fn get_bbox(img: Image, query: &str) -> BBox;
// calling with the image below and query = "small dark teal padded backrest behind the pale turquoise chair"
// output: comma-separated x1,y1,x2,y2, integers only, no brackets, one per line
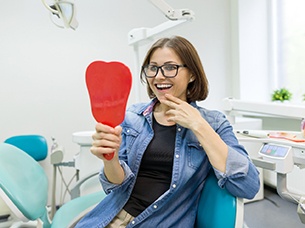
4,135,48,161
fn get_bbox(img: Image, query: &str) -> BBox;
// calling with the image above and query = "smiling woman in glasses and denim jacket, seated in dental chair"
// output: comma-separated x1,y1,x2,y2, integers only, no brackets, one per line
77,36,260,228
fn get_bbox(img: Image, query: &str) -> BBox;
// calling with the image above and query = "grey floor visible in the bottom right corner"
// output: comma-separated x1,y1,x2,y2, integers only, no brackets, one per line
244,186,305,228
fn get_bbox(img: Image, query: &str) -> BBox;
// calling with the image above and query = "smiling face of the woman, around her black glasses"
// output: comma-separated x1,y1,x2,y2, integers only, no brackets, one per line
147,47,191,101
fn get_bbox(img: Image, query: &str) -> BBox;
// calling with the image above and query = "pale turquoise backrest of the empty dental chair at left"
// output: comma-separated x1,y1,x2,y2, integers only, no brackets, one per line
0,143,50,227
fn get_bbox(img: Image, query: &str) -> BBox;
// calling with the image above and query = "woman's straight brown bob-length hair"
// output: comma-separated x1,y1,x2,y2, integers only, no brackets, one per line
140,36,209,102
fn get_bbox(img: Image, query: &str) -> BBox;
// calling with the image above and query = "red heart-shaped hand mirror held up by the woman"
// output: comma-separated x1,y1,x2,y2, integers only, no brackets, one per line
86,61,132,160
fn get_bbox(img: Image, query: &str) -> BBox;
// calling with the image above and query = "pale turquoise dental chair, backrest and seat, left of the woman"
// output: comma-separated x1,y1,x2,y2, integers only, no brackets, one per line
0,143,105,228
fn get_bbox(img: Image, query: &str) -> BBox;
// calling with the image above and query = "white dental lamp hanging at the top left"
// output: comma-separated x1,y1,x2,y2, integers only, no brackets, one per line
42,0,78,30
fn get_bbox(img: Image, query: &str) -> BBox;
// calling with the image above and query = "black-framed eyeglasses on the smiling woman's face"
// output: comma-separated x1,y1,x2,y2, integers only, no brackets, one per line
142,64,186,78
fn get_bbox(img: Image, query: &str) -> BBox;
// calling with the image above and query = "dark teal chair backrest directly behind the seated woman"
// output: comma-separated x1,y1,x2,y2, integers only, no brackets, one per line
195,170,243,228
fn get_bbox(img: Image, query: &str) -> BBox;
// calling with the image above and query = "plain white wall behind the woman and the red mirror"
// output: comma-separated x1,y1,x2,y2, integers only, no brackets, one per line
0,0,232,203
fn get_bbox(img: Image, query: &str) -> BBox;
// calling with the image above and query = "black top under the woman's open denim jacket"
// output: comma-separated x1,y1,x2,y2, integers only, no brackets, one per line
124,118,176,217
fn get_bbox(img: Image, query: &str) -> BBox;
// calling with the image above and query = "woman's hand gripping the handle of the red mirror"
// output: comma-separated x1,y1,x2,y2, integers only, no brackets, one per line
90,123,122,162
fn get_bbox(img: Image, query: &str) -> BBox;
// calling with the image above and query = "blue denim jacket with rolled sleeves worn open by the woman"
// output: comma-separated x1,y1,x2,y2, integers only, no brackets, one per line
76,100,260,228
